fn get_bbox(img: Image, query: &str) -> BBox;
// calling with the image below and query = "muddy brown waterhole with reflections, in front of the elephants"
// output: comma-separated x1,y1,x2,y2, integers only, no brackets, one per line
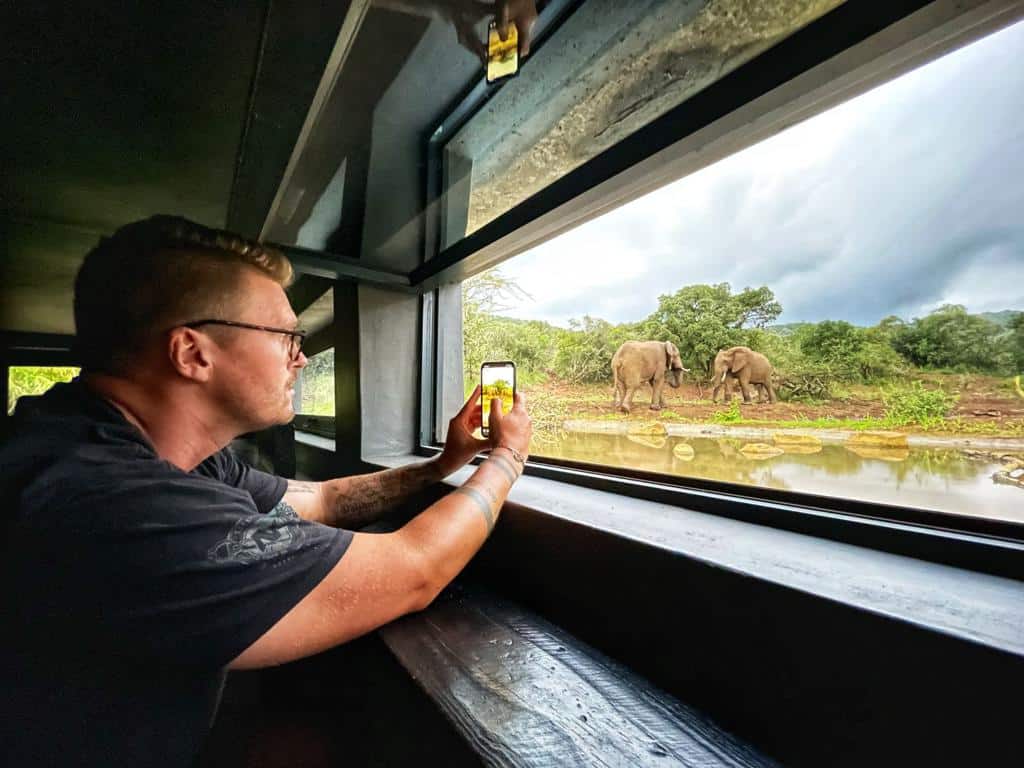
532,433,1024,520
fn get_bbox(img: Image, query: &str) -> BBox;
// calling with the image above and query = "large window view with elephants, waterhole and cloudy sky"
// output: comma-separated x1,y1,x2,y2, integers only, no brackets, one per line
452,24,1024,520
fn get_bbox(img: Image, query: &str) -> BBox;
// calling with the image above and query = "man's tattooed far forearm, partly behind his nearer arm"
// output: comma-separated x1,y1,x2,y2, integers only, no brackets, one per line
323,459,445,528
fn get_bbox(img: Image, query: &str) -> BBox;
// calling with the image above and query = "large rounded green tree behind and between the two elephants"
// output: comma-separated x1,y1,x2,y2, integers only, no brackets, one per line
643,283,782,374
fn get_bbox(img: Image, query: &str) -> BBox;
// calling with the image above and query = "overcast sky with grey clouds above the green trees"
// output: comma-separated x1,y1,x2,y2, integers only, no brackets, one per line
502,23,1024,326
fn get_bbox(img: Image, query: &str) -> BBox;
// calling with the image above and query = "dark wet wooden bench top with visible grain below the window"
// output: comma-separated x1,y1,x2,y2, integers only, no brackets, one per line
380,586,775,768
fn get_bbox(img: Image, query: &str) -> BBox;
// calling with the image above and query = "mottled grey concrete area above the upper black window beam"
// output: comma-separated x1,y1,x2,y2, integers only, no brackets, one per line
443,0,842,247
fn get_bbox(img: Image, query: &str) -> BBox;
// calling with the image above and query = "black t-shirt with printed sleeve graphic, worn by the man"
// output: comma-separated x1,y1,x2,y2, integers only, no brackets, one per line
0,381,352,766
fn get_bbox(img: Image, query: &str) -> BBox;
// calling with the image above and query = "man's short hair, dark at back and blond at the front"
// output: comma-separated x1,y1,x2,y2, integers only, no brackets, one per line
75,216,293,374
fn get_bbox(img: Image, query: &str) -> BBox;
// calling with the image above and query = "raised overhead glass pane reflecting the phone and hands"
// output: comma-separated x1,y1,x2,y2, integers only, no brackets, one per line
264,0,842,272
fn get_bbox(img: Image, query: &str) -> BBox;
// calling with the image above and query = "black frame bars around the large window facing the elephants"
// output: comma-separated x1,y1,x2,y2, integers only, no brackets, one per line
411,0,1024,579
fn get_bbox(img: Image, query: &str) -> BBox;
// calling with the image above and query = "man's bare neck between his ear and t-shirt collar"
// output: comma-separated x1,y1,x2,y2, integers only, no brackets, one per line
82,373,236,472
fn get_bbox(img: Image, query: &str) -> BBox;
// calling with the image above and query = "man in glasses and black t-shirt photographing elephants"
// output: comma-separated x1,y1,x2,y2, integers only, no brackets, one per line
0,216,530,766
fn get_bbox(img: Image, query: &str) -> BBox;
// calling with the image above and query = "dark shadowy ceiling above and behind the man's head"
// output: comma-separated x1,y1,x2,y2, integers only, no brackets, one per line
0,0,347,334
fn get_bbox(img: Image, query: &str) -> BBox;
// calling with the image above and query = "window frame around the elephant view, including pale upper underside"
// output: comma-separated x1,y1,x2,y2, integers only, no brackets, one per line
411,0,1024,579
